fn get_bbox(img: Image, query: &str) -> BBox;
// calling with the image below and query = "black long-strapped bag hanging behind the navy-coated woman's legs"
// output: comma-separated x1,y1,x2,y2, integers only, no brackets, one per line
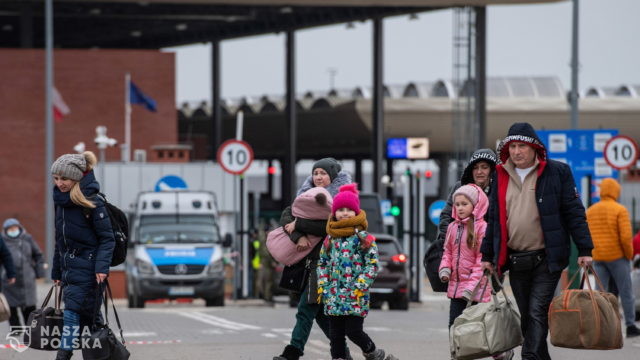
82,279,131,360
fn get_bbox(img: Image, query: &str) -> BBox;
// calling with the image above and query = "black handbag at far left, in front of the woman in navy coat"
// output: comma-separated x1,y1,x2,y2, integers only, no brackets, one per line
23,284,64,351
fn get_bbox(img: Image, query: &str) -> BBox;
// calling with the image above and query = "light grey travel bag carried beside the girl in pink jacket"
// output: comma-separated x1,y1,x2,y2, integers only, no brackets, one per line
449,273,523,360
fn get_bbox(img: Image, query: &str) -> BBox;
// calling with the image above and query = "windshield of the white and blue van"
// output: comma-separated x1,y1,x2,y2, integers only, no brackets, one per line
138,215,221,244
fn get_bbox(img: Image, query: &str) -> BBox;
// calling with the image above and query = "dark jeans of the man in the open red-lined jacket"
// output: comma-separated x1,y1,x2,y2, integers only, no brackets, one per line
509,258,562,360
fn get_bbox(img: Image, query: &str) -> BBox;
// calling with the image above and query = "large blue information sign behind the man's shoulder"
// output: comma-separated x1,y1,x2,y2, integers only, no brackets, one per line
537,129,618,203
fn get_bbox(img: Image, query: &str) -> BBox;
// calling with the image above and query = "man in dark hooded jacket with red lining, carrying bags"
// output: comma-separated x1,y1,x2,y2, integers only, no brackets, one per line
480,123,593,360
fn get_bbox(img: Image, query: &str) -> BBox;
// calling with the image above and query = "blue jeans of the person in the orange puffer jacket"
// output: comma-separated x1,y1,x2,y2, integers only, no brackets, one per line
593,258,635,326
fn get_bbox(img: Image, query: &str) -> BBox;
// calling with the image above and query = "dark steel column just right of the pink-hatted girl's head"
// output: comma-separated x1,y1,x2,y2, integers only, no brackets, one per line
371,17,384,196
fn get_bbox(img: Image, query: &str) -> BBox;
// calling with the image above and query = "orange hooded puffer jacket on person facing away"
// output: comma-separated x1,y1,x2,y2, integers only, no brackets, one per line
587,178,633,261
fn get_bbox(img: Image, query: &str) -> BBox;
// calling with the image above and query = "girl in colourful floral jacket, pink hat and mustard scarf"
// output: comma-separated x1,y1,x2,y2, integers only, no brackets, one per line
317,184,396,360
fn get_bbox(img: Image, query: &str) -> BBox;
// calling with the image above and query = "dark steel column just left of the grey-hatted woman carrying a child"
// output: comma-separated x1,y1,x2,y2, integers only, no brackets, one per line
282,30,298,206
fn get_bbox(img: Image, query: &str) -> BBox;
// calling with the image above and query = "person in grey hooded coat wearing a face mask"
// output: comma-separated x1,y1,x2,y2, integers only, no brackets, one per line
1,218,44,326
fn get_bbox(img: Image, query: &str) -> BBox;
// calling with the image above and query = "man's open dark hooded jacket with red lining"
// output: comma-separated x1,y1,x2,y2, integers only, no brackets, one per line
480,123,593,272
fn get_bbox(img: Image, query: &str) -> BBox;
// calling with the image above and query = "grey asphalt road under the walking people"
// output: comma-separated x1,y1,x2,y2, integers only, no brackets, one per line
0,295,640,360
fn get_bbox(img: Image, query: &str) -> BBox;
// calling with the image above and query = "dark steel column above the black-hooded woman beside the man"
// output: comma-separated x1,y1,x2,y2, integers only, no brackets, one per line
475,6,487,149
